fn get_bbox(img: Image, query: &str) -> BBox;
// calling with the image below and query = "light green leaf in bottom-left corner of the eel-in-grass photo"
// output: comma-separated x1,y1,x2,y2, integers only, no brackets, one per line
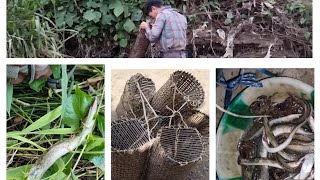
7,164,32,180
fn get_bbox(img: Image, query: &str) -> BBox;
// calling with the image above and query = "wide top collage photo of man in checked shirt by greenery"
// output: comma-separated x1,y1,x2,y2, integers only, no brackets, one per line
6,0,313,58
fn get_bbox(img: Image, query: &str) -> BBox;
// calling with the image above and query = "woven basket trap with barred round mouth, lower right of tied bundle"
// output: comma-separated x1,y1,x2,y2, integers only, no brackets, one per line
146,127,203,180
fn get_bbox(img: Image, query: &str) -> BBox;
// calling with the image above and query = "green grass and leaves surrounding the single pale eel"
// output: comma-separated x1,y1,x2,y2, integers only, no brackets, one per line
6,65,105,180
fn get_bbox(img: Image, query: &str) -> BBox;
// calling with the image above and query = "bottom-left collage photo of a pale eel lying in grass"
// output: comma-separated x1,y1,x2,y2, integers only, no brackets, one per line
6,64,105,180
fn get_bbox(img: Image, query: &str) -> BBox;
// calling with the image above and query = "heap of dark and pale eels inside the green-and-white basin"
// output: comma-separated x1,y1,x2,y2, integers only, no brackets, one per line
238,96,314,180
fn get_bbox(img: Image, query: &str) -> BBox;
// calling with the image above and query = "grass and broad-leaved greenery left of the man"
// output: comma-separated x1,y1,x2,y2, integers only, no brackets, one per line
7,0,174,58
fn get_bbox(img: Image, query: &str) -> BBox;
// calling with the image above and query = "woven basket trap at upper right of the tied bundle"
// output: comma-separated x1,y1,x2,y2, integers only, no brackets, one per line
151,71,204,115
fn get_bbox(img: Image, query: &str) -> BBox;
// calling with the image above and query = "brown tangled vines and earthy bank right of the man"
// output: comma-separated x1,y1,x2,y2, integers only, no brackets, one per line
187,0,313,57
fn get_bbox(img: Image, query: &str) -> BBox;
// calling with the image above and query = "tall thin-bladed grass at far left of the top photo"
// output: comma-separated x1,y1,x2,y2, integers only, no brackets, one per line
7,0,77,58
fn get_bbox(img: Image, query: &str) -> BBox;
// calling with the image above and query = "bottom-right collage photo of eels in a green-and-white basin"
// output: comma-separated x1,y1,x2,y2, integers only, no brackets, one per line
216,68,315,180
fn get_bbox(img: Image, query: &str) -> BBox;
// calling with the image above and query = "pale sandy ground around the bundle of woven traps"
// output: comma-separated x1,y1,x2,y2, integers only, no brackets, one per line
111,70,210,180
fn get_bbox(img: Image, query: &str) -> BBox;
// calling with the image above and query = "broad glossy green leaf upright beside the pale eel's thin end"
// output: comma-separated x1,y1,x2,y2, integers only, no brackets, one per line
63,87,93,129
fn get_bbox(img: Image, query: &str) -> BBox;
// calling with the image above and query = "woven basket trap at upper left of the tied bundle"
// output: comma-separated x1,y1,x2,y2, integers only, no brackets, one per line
116,73,156,119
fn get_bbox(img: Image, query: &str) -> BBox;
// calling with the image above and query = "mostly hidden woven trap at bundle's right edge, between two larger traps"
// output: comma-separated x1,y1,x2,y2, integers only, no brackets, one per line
183,110,209,144
